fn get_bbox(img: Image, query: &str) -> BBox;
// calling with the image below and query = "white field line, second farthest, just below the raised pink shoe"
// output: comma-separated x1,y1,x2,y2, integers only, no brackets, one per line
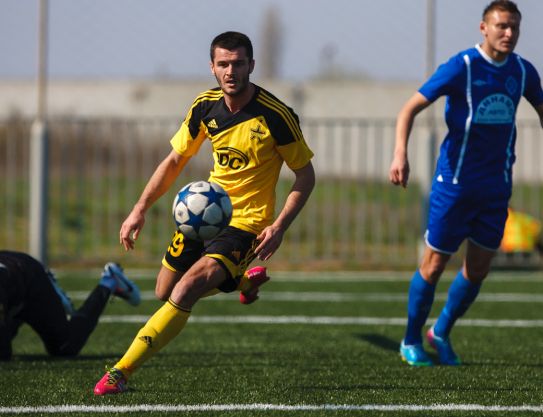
68,290,543,303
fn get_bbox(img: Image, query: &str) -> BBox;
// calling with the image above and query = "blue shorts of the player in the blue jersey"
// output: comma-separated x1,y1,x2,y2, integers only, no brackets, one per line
424,181,511,254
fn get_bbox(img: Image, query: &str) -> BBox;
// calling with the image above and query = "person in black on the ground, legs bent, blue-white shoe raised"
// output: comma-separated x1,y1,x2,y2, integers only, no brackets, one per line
0,250,140,361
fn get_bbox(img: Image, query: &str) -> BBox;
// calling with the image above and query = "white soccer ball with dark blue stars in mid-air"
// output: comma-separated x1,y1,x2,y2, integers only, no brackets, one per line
172,181,232,240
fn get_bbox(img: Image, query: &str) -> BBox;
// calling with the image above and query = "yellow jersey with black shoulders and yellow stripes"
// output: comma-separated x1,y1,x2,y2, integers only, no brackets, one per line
170,86,313,234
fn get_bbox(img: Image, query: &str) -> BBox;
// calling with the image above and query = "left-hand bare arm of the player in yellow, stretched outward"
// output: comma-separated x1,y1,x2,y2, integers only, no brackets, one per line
119,150,189,250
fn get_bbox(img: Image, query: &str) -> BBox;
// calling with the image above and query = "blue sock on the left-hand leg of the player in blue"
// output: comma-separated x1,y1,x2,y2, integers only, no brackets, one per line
404,269,436,345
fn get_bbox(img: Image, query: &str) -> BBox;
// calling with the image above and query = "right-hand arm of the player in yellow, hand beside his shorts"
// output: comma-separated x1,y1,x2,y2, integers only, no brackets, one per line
255,161,315,260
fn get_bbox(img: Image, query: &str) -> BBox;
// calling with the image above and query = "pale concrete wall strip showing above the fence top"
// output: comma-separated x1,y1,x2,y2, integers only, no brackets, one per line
0,79,536,120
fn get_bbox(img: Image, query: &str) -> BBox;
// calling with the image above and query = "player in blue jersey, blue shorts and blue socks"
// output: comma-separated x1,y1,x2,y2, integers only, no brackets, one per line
389,0,543,366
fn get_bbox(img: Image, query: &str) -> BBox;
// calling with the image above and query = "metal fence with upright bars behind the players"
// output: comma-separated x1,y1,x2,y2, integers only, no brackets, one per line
0,118,543,269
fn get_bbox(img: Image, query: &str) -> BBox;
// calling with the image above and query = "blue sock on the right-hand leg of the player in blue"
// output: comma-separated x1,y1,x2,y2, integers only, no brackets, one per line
434,270,481,338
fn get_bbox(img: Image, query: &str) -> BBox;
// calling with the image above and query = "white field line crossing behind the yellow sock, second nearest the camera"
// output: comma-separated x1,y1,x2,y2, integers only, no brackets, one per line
100,315,543,328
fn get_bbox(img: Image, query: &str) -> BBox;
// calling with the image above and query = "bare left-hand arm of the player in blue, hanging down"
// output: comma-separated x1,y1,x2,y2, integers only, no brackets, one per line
389,92,431,188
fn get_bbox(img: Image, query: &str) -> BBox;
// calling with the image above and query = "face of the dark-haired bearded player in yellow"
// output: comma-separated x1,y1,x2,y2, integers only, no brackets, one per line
210,48,255,97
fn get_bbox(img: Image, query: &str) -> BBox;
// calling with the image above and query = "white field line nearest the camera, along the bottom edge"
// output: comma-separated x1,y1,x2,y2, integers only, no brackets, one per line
0,404,543,416
